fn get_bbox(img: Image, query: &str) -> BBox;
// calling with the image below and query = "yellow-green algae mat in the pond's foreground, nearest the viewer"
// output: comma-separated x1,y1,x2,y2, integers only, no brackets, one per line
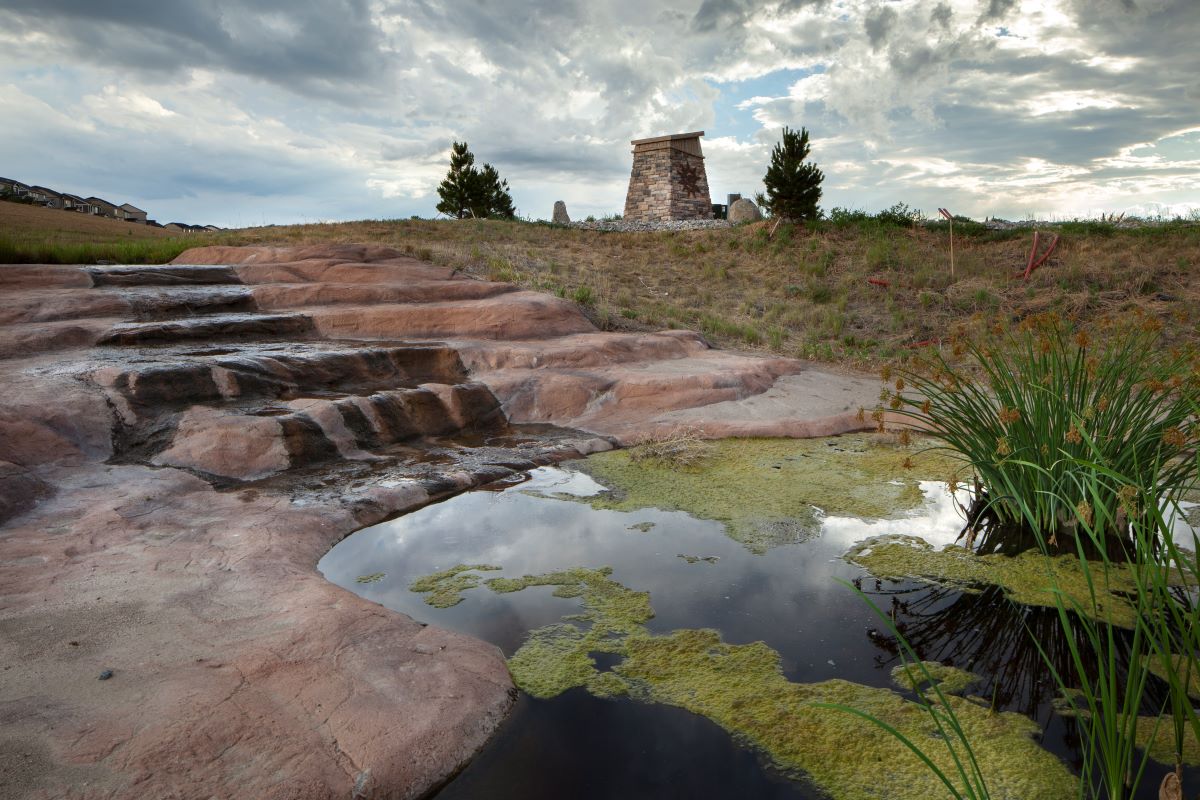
413,567,1076,800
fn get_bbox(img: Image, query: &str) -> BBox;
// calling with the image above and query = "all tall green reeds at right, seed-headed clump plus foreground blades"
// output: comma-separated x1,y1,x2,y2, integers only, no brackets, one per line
856,317,1200,800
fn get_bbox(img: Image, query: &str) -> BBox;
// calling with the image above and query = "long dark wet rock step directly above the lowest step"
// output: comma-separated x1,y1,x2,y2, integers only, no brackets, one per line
92,343,467,407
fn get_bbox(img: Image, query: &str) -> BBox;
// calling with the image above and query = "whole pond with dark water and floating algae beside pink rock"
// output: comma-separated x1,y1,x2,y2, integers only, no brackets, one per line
319,437,1195,800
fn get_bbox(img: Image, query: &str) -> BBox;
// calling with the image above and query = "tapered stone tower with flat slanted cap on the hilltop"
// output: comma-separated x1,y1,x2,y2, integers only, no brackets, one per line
625,131,713,222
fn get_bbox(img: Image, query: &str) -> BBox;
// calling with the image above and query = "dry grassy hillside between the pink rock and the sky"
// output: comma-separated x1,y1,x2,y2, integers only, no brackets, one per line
0,204,1200,368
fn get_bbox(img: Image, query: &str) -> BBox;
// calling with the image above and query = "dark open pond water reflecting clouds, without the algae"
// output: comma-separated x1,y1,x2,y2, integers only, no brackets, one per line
319,468,1195,800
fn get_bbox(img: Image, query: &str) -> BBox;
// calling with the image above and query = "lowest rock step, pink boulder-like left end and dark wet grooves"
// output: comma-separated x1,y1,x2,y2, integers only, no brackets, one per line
150,383,506,481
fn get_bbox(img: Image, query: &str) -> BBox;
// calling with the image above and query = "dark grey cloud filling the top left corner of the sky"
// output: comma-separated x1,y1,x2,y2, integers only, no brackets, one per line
0,0,384,97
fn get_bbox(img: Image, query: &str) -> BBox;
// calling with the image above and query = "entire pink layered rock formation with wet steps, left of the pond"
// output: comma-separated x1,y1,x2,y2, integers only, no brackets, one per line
0,245,877,799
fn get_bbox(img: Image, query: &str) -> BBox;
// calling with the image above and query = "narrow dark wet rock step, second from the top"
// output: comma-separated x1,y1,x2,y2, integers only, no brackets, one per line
97,314,314,347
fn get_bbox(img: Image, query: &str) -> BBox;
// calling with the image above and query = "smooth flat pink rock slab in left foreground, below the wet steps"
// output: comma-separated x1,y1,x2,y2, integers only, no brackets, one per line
0,464,511,799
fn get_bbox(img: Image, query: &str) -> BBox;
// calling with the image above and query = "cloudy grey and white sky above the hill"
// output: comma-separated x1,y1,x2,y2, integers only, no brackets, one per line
0,0,1200,225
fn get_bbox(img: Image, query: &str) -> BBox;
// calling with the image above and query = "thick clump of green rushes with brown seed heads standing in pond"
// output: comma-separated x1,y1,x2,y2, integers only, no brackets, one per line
889,313,1200,549
